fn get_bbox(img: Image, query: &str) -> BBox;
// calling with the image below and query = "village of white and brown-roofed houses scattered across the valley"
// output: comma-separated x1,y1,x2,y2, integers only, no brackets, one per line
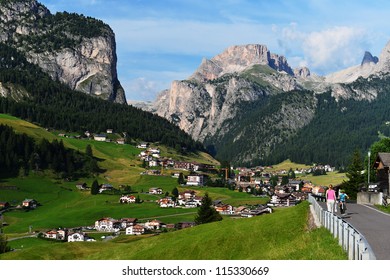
0,137,334,242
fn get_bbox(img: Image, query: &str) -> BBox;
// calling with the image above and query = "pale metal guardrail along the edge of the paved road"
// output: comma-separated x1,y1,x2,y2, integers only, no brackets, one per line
309,195,376,260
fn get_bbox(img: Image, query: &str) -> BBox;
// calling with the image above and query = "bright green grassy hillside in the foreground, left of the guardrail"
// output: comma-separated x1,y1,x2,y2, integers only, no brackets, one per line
0,202,347,260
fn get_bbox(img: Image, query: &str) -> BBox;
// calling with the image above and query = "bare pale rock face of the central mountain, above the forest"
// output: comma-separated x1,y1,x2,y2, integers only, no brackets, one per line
153,45,310,144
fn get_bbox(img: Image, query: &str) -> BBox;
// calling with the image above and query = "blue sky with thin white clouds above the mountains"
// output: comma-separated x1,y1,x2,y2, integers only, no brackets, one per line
38,0,390,101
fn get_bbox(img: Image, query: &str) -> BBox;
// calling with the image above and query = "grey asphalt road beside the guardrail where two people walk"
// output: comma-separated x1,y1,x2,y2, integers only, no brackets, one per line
320,203,390,260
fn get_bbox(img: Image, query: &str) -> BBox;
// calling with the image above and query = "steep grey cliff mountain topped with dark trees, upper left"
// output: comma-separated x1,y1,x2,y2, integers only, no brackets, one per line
0,0,126,104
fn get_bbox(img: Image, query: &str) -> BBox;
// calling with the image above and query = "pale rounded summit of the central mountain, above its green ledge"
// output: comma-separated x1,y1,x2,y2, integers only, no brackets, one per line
189,44,294,82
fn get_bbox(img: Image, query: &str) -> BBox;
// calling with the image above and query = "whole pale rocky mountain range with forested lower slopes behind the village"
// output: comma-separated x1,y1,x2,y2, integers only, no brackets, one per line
151,41,390,165
